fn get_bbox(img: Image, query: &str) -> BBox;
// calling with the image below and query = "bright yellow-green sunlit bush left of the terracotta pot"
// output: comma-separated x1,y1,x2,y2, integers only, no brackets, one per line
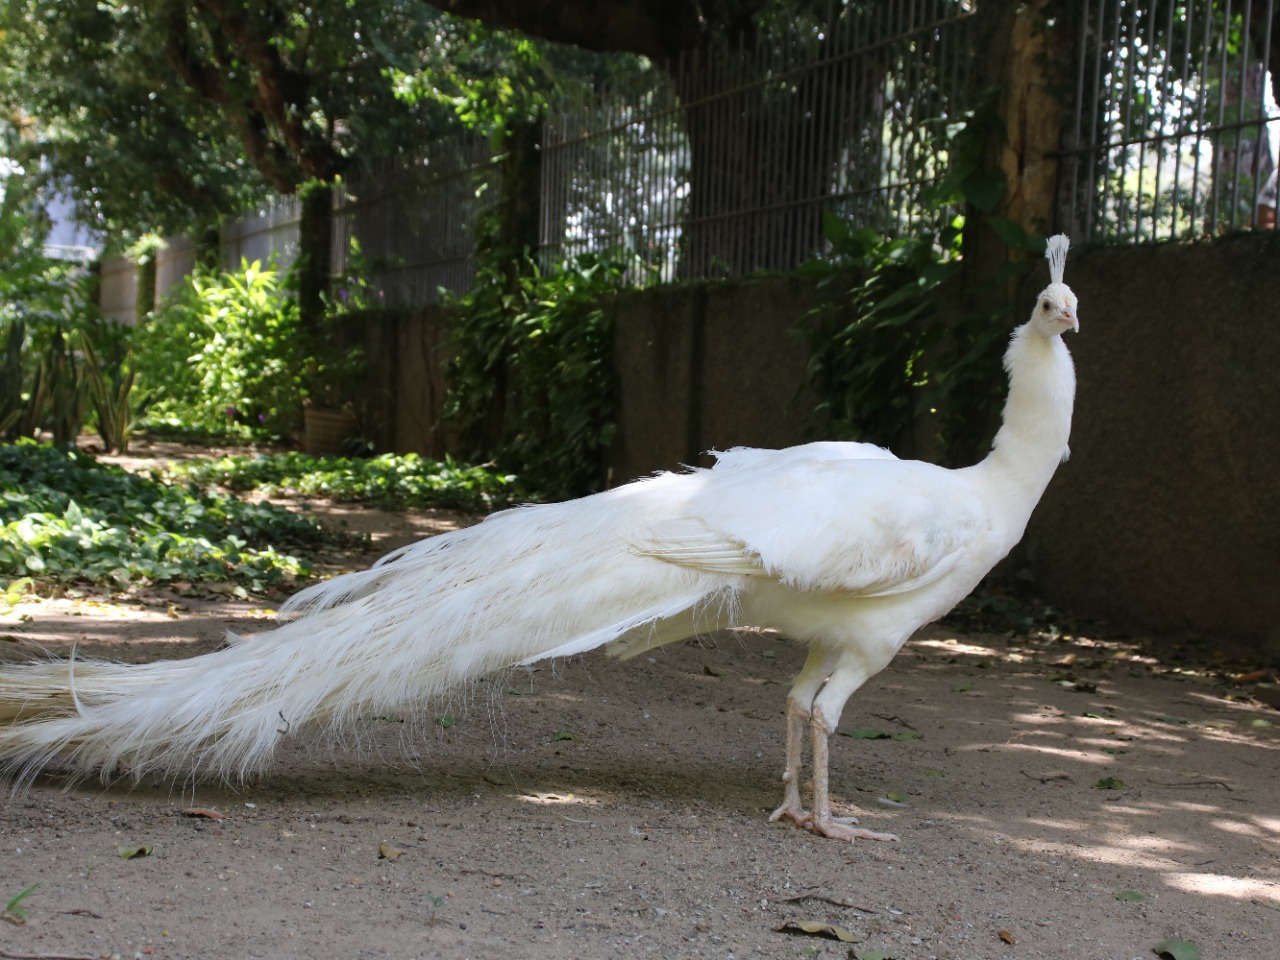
136,262,308,439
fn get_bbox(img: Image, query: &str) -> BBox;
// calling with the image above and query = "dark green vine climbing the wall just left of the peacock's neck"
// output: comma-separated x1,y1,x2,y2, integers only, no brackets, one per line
797,111,1044,465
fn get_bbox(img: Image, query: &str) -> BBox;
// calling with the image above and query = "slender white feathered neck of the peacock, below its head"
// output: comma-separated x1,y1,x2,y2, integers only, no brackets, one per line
978,324,1075,527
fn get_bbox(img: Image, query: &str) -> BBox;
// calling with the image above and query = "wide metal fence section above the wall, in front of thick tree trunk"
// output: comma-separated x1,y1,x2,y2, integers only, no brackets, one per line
540,0,973,283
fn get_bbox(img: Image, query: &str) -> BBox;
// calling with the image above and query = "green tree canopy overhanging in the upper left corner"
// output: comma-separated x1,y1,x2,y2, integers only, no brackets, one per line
0,0,650,244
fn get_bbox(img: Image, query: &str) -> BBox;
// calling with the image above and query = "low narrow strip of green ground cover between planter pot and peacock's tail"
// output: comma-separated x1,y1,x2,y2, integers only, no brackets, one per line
168,453,517,511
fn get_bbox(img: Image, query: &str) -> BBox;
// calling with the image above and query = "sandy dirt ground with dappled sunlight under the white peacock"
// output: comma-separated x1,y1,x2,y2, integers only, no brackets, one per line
0,460,1280,960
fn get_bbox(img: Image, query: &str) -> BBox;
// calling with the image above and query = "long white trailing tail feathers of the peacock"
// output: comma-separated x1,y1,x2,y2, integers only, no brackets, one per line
0,475,723,780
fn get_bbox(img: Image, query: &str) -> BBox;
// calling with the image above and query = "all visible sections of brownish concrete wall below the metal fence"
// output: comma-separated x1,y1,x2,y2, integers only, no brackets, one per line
370,234,1280,657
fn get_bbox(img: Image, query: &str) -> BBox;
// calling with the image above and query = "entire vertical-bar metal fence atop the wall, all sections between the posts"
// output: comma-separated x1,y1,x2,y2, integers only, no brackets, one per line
120,0,1280,312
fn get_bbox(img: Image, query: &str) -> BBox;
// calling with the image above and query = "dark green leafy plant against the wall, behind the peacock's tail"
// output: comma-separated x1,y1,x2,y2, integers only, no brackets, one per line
444,248,621,499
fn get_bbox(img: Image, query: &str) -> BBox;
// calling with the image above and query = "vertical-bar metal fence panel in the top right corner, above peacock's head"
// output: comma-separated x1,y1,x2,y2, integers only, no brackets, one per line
1062,0,1280,242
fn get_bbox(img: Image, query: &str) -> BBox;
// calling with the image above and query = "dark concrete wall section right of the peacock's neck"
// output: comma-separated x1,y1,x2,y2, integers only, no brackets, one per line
1024,234,1280,655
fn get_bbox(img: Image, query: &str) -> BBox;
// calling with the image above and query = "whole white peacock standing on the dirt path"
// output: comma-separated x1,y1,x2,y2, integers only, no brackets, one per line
0,237,1078,837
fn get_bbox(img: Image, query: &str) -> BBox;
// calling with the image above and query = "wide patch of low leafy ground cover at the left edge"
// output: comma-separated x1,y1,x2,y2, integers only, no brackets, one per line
0,440,345,593
